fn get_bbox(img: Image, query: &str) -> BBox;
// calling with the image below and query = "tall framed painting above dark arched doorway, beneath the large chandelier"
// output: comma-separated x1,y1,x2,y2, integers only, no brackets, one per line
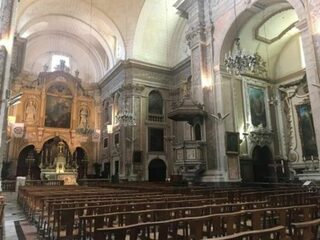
248,86,267,127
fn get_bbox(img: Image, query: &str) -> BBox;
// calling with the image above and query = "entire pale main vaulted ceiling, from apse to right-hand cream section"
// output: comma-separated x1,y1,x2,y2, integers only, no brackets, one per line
16,0,186,82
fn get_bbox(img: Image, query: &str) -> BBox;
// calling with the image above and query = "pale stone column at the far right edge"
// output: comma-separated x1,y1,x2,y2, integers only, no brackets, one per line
297,0,320,160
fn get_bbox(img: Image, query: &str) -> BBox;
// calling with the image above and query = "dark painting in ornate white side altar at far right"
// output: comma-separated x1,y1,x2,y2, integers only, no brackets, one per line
296,103,318,158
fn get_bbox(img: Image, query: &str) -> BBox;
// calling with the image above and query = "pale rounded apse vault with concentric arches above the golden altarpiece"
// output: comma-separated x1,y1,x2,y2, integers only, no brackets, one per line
17,0,126,81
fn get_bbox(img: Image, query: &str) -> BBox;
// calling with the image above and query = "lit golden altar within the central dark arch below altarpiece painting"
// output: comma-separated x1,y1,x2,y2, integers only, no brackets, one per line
40,138,78,185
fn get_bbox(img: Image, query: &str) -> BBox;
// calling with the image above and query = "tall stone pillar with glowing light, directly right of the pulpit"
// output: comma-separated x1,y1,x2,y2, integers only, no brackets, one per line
178,0,226,181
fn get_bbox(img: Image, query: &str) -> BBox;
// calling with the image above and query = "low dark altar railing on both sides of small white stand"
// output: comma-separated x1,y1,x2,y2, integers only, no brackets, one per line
1,180,64,192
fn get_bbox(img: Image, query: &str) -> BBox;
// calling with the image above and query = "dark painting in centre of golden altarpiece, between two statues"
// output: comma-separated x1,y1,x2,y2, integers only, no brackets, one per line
45,95,72,128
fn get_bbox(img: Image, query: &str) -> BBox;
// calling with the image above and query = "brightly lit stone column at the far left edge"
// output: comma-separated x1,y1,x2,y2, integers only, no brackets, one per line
0,0,18,191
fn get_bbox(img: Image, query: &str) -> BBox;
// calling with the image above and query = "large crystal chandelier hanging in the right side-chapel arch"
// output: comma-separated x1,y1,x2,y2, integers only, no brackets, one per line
224,38,266,75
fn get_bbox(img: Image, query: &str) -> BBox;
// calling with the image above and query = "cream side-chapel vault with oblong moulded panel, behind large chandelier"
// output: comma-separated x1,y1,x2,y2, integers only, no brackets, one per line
239,1,304,79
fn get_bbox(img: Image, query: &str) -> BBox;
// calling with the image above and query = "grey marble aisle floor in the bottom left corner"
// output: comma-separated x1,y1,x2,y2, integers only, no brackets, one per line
2,192,38,240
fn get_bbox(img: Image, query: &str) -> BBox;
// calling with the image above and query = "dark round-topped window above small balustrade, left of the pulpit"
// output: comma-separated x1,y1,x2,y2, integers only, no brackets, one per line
148,91,163,122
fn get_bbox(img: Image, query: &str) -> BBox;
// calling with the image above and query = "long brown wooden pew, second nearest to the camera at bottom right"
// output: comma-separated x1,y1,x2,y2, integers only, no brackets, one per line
93,206,314,240
